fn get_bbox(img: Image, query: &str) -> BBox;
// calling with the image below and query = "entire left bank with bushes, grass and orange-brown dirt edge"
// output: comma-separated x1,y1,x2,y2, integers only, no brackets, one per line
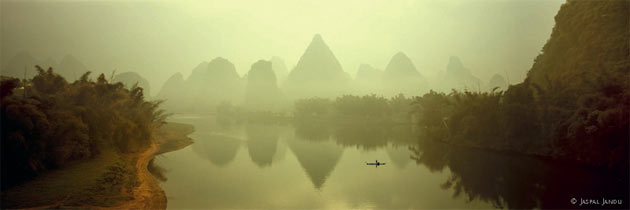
1,67,192,209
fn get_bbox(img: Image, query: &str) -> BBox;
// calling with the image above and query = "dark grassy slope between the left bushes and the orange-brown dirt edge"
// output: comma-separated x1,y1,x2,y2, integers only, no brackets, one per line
2,150,139,208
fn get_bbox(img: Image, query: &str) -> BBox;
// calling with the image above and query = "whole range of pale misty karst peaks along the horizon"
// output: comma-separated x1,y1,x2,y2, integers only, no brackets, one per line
1,34,520,112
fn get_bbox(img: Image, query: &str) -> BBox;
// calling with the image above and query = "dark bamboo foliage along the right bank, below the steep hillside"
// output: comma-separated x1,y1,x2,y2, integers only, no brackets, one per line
414,83,630,168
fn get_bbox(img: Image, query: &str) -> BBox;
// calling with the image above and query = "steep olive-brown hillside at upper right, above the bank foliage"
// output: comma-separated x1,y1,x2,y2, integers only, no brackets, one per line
527,0,630,91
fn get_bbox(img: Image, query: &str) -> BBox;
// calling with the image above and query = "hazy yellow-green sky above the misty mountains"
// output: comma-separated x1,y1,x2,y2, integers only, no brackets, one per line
0,0,564,94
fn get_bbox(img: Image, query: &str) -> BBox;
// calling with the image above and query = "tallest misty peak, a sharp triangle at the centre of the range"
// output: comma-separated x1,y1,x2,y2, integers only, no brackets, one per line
283,34,350,98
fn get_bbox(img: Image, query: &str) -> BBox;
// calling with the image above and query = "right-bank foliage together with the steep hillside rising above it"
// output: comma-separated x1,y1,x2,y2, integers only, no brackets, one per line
415,0,630,169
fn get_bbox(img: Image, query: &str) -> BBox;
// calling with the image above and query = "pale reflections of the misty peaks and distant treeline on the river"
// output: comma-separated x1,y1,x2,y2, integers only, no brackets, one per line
192,120,415,189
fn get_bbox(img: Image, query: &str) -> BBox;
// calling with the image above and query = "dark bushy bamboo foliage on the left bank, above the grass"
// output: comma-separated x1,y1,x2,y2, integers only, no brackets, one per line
0,66,165,188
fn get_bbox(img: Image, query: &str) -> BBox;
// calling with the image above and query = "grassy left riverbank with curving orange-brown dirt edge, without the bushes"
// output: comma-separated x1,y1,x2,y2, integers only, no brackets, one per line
2,123,193,209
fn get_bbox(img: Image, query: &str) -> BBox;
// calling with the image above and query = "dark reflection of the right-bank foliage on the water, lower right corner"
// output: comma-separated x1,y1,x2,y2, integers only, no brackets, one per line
413,141,628,209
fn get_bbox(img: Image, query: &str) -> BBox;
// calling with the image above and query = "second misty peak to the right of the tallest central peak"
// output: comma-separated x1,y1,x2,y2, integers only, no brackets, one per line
382,52,428,96
